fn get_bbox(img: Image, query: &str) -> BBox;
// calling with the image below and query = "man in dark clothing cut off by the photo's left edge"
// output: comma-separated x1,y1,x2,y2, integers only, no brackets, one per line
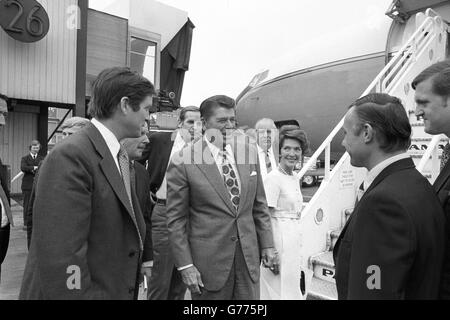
0,94,14,281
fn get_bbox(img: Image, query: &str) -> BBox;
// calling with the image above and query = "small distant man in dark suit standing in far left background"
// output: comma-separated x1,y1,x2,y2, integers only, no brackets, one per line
20,140,44,230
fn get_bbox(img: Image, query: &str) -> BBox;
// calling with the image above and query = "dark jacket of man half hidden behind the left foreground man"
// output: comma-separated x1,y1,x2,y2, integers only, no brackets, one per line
134,161,153,262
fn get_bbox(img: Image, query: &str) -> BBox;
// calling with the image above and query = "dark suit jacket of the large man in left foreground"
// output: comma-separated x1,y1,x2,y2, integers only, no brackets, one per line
19,124,145,300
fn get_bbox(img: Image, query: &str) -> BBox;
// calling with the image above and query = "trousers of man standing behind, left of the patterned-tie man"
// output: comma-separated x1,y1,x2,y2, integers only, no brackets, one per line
148,204,186,300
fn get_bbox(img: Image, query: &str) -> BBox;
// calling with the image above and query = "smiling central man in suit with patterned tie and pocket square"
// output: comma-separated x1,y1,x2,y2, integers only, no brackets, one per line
167,96,276,300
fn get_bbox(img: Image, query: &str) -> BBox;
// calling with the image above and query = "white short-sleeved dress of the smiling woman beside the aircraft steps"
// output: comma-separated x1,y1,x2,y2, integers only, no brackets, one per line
261,169,304,300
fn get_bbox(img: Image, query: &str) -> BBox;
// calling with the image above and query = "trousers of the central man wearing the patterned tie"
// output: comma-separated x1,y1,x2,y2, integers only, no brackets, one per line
192,242,260,300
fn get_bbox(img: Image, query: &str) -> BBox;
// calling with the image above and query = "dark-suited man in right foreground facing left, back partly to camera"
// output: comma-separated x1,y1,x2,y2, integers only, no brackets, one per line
334,93,445,300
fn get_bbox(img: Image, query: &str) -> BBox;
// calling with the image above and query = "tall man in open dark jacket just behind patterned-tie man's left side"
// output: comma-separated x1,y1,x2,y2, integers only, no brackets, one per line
139,107,201,300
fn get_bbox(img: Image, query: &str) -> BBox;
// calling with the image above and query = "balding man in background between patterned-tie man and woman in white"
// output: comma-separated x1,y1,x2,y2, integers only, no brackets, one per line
255,119,279,181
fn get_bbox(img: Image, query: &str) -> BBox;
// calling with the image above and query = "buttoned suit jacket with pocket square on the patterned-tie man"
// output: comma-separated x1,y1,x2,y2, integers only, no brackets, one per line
167,139,274,291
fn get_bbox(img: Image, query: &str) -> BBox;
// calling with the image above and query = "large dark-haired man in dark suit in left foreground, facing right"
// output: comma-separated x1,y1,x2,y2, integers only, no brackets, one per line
19,67,155,300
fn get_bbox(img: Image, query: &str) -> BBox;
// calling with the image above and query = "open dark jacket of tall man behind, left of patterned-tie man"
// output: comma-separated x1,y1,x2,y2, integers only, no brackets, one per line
143,132,175,194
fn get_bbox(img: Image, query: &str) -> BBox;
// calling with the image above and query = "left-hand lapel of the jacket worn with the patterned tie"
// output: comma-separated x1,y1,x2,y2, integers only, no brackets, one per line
198,140,236,215
